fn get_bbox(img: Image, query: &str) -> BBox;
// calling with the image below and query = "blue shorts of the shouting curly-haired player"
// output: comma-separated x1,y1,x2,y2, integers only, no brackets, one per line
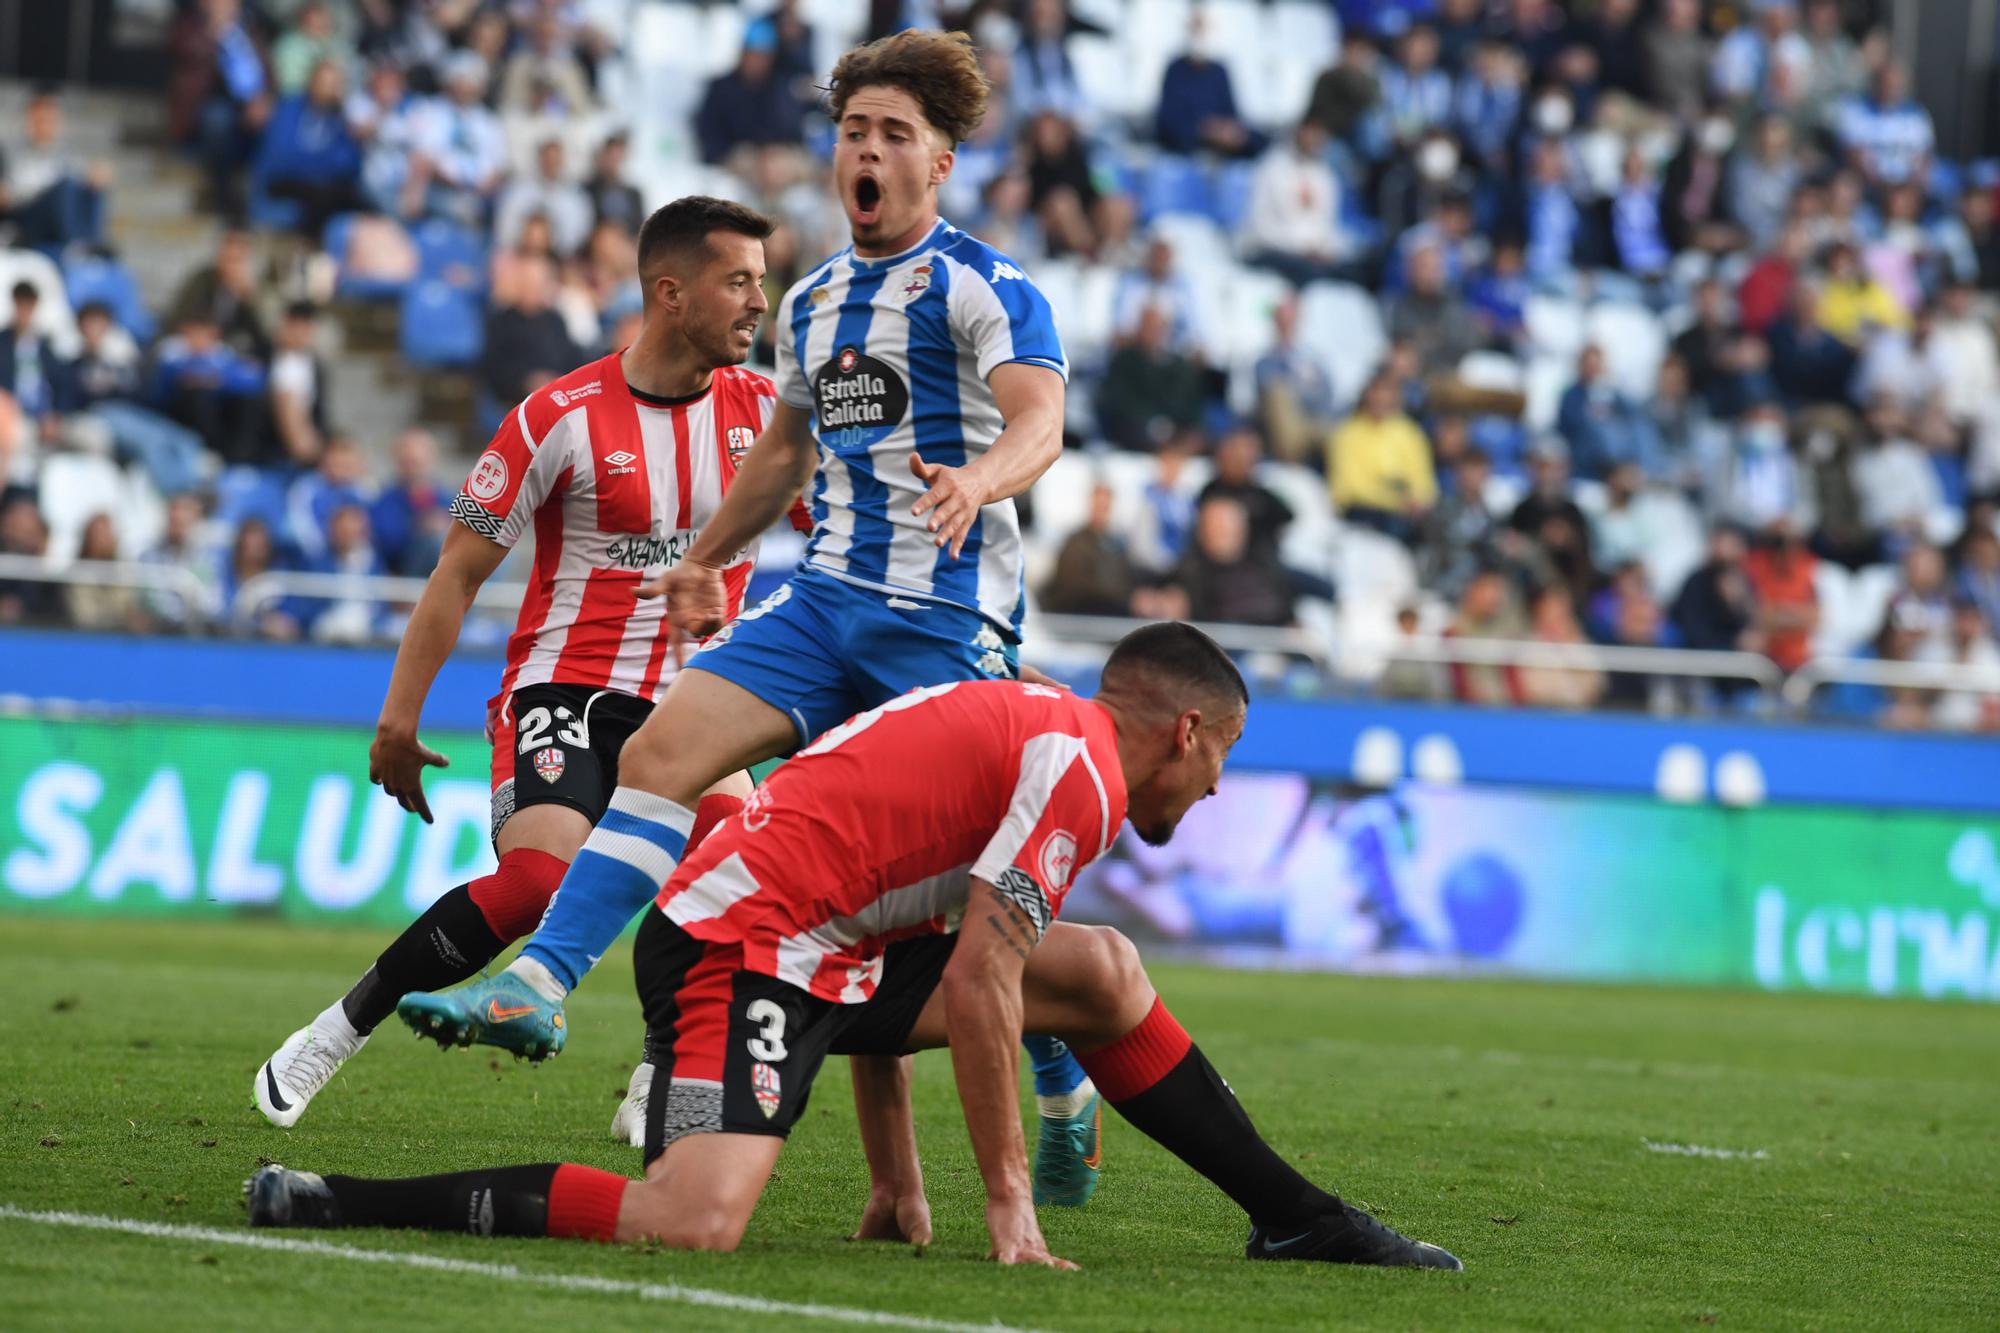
688,568,1020,745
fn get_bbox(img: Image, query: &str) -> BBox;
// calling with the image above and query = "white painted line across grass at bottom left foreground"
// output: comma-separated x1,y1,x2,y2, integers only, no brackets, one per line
0,1203,1056,1333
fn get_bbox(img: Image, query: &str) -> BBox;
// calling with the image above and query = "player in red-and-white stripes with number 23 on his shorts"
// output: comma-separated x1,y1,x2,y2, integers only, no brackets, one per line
256,196,804,1143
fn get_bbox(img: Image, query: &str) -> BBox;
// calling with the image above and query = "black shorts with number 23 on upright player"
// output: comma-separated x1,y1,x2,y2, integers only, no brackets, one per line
492,685,652,839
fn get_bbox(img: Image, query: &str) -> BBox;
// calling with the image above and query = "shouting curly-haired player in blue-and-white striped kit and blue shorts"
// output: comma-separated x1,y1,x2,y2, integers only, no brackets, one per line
404,30,1100,1203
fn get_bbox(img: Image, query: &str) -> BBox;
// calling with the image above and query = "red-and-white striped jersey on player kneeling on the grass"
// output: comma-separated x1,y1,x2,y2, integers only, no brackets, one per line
658,681,1126,1005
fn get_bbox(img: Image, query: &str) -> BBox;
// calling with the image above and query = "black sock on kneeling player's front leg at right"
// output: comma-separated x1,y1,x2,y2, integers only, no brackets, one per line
1112,1047,1338,1227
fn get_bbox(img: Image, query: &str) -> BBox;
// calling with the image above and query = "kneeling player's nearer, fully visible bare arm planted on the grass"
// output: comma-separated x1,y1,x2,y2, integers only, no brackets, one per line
940,877,1076,1269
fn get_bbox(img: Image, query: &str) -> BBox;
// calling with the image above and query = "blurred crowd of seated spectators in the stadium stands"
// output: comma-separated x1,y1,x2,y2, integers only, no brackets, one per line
0,0,2000,729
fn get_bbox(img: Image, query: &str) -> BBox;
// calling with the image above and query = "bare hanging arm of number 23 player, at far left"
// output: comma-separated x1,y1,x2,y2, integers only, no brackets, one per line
368,522,506,825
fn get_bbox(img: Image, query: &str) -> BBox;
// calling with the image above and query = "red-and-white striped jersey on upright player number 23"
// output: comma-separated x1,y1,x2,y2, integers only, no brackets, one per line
452,352,798,701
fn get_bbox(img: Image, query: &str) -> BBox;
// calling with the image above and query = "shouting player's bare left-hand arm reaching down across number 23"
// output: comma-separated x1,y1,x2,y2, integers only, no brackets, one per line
638,400,820,634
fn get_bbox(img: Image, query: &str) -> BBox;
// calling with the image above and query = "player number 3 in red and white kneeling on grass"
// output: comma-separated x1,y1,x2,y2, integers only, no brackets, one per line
248,624,1460,1269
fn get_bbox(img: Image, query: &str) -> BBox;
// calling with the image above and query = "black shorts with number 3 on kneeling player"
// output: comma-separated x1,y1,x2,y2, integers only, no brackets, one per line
632,911,956,1163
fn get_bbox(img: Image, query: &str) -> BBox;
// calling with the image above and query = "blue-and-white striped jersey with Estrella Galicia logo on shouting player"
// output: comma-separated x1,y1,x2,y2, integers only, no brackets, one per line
776,220,1070,638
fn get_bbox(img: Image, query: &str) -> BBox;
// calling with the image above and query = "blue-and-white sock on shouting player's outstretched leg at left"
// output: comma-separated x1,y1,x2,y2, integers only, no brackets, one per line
520,787,694,989
